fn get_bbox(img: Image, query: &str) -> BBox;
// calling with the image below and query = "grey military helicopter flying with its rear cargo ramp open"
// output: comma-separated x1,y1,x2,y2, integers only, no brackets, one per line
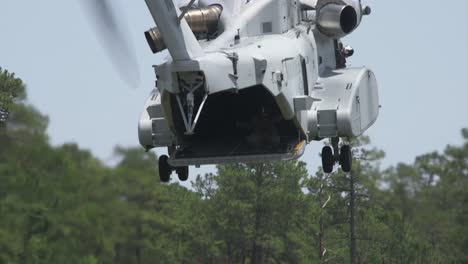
86,0,379,182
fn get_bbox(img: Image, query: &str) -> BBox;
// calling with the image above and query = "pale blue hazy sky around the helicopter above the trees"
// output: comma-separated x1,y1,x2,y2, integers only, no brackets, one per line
0,0,468,180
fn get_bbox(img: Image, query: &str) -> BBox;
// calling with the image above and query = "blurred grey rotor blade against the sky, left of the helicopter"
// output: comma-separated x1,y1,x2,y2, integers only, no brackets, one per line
81,0,140,87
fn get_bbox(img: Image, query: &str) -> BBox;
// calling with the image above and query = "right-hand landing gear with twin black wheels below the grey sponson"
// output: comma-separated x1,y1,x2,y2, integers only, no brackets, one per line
322,138,353,173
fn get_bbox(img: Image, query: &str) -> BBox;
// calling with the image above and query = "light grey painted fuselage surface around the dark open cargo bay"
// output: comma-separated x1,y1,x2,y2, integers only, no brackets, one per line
139,0,379,166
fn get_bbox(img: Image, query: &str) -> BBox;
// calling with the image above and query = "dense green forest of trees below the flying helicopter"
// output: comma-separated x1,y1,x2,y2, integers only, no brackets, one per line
0,69,468,264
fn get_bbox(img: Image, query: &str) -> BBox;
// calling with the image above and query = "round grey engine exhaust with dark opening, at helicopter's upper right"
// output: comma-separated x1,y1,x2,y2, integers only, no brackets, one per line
317,3,359,39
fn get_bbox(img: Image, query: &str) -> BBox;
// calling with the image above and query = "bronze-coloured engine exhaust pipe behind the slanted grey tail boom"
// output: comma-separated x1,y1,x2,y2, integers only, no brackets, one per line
145,4,223,53
